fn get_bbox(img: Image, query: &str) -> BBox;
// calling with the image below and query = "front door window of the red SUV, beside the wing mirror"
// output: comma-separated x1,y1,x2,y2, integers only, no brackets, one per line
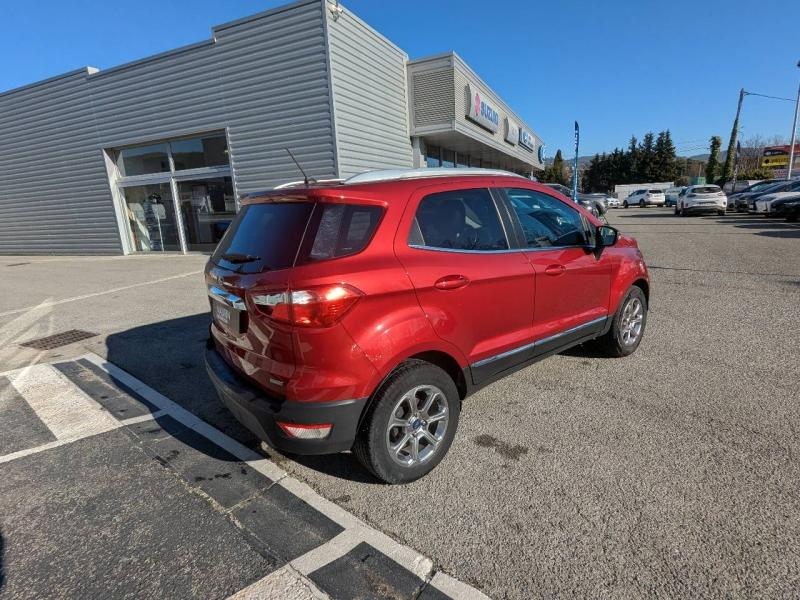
505,188,586,248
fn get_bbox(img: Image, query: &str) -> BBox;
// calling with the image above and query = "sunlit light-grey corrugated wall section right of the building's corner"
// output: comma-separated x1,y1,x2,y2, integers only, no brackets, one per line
327,10,412,177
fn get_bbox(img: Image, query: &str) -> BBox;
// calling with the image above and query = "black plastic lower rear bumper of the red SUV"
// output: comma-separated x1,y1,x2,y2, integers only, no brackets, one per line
205,348,367,454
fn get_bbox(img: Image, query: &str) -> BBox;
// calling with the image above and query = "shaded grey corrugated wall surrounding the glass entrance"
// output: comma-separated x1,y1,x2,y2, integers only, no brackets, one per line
0,0,338,254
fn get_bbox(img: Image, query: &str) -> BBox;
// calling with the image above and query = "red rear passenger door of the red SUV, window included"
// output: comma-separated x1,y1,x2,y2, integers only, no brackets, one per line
395,183,535,383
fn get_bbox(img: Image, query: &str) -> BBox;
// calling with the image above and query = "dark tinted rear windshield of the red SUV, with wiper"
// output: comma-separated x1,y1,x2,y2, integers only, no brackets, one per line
211,202,314,273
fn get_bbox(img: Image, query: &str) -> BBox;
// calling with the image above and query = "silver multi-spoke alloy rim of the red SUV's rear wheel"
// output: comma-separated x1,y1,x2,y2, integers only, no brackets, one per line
386,385,449,467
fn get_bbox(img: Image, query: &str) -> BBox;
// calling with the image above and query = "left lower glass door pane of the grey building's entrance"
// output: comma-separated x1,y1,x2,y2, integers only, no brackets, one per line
122,182,181,252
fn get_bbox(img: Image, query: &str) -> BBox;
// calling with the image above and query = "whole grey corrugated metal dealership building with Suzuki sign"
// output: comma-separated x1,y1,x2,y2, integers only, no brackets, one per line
0,0,543,254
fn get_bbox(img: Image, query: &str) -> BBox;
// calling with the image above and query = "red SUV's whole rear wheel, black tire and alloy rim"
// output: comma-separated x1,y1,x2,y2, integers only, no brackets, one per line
353,360,461,484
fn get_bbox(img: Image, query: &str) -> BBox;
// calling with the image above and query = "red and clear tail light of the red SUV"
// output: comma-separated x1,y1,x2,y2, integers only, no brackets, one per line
252,283,364,327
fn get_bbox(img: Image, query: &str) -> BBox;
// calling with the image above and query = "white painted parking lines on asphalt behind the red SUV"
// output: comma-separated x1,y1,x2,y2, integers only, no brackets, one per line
0,354,488,600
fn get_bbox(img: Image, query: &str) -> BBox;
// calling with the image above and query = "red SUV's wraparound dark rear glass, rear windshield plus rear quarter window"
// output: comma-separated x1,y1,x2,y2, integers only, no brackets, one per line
211,202,383,273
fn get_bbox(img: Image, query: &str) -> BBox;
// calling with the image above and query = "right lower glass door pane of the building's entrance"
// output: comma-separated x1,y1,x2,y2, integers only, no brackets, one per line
177,177,236,252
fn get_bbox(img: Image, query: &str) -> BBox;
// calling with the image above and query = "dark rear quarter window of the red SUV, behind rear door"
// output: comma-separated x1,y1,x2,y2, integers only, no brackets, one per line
308,204,383,260
